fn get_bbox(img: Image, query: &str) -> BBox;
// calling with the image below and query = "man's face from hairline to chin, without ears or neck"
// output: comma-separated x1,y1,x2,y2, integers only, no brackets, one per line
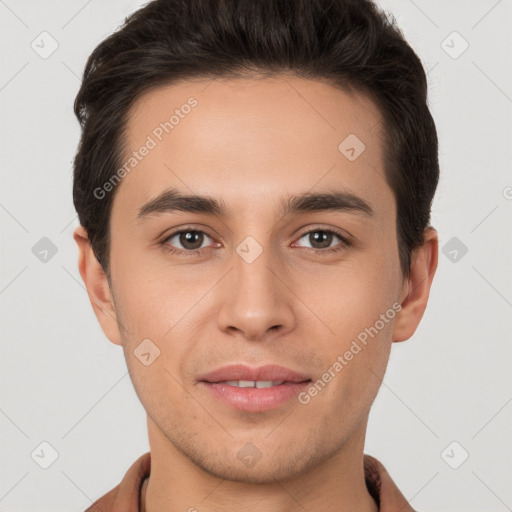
81,76,416,482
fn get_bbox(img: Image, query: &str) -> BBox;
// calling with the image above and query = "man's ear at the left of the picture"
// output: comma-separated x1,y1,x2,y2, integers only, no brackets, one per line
73,226,121,345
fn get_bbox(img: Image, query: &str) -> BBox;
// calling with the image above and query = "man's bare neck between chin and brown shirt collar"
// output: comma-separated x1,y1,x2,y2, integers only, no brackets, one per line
142,417,378,512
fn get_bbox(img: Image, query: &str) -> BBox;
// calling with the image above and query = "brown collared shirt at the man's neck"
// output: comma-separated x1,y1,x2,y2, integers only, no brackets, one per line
85,452,415,512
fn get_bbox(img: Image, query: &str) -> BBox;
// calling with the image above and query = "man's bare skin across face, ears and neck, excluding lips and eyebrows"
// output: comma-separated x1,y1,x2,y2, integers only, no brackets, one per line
74,75,438,512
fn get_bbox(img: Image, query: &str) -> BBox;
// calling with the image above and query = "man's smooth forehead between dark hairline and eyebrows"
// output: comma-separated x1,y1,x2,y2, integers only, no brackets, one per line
113,76,393,222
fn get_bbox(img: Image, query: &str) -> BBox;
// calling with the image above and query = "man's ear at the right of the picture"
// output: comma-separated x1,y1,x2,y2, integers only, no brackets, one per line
393,226,439,341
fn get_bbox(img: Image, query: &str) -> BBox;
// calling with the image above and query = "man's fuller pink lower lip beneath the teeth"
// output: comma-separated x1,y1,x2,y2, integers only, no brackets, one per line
200,381,311,412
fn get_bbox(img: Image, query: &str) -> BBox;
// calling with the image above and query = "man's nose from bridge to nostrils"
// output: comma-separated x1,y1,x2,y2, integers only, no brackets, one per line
218,240,296,341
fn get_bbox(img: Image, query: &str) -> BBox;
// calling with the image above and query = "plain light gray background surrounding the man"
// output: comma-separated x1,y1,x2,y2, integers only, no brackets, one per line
0,0,512,512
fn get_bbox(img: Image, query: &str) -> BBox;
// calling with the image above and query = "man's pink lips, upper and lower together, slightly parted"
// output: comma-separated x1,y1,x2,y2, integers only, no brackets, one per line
198,364,311,412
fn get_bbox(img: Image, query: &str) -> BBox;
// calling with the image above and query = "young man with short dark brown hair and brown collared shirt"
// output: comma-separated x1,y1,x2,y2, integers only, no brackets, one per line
73,0,439,512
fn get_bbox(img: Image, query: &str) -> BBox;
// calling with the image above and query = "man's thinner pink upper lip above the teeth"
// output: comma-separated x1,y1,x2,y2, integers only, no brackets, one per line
198,364,310,382
